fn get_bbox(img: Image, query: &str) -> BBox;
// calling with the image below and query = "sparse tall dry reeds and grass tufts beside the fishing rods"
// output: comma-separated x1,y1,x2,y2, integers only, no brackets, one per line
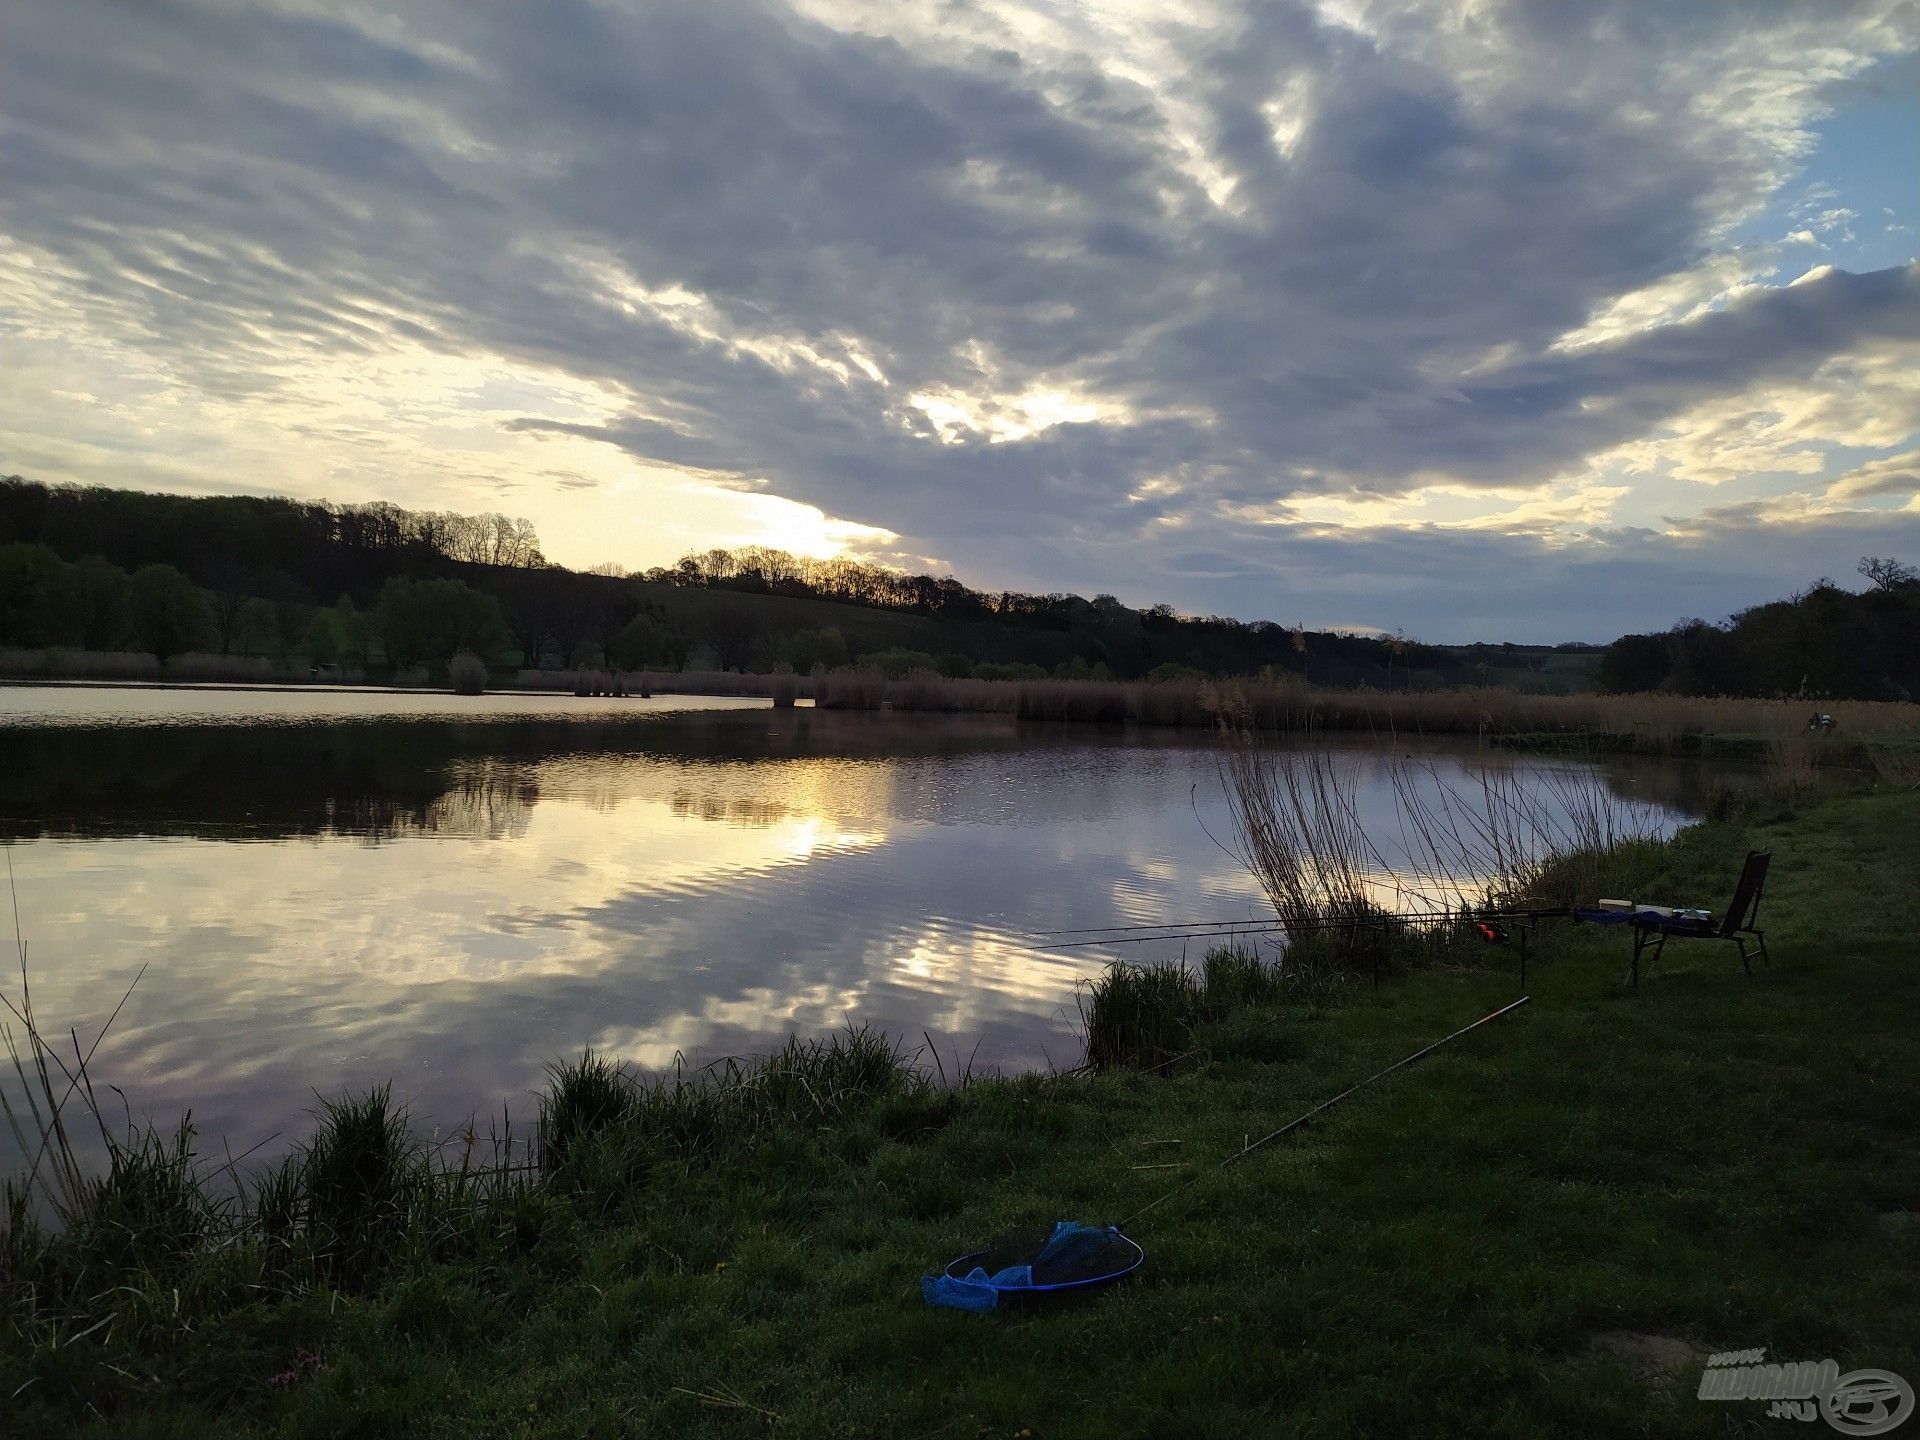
1081,728,1661,1029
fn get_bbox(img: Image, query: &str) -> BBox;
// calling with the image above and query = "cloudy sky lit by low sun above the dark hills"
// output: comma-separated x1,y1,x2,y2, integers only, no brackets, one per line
0,0,1920,641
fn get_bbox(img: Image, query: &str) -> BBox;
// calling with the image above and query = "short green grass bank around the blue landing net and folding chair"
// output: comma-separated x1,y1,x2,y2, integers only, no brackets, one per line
0,793,1920,1440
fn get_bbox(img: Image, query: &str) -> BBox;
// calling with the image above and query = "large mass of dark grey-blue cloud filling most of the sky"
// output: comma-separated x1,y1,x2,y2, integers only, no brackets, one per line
0,0,1920,632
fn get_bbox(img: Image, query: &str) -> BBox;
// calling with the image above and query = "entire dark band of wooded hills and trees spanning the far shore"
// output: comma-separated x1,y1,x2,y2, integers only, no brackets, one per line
0,476,1920,699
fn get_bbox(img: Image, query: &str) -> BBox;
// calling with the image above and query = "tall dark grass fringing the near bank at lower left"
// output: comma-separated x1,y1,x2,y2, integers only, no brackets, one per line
0,970,940,1352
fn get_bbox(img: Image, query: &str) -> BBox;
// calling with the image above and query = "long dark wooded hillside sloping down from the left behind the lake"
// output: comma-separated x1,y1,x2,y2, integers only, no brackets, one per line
0,476,1473,684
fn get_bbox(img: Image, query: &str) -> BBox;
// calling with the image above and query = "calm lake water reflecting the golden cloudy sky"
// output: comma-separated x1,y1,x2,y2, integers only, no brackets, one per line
0,685,1703,1175
